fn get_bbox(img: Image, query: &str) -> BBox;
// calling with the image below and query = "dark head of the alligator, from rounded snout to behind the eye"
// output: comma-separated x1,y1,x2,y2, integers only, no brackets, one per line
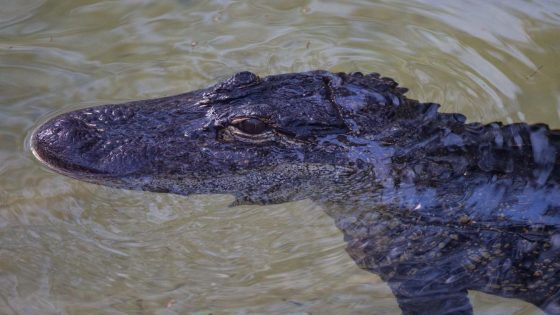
32,71,416,203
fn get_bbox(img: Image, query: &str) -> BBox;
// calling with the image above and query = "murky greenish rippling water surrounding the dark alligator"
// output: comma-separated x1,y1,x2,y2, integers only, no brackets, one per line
0,0,560,314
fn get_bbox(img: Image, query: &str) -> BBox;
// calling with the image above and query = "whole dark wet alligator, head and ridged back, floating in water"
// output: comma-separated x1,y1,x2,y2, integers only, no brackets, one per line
32,70,560,314
